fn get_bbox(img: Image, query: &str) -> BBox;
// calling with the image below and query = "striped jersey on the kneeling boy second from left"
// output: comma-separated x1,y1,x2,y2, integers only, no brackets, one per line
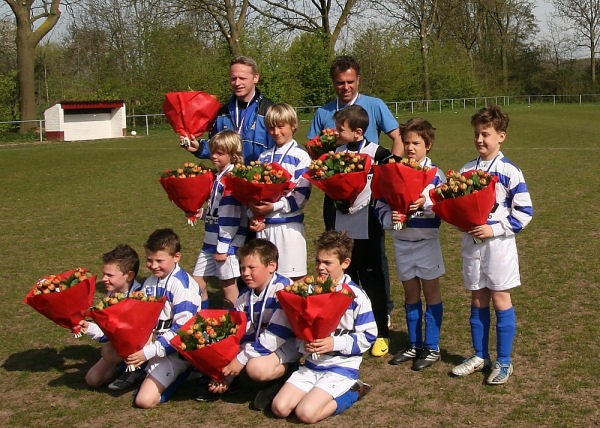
142,264,202,359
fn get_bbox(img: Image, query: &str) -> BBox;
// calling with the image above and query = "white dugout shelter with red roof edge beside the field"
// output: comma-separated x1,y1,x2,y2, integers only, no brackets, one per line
44,100,127,141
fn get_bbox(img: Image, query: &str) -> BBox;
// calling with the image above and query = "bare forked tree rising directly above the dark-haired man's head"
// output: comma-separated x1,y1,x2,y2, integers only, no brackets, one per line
250,0,358,57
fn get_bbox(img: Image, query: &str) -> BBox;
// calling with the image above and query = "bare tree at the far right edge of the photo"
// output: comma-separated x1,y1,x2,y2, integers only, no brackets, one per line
554,0,600,91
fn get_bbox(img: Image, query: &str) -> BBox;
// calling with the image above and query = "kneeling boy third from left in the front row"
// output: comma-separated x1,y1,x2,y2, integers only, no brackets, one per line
209,239,300,410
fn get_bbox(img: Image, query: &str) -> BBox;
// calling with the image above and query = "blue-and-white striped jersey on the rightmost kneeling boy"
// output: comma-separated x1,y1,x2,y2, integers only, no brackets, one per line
298,274,377,379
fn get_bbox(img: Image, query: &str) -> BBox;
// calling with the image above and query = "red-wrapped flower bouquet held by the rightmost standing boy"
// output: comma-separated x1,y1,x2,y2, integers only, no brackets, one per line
429,170,498,231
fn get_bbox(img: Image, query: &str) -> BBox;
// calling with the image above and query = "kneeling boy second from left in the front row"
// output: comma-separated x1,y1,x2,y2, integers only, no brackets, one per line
125,229,201,409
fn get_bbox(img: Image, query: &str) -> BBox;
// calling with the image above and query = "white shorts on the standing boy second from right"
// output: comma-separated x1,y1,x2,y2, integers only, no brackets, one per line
394,239,446,281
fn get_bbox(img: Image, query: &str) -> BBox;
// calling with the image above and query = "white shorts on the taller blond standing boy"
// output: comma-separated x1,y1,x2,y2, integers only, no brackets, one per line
256,222,306,278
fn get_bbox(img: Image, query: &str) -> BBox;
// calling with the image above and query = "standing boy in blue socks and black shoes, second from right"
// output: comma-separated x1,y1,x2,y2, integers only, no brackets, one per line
375,117,446,370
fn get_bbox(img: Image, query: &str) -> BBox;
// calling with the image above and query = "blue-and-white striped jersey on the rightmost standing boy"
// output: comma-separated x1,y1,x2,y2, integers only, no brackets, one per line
460,152,533,236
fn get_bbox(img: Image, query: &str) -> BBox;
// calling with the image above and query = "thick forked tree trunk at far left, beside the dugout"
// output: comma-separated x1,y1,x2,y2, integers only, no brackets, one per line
4,0,60,133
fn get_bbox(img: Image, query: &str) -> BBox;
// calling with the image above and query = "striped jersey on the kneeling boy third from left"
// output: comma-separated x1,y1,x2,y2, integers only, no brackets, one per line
235,272,296,365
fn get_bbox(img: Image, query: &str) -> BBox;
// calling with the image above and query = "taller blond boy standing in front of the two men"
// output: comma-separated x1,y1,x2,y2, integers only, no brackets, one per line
249,103,310,281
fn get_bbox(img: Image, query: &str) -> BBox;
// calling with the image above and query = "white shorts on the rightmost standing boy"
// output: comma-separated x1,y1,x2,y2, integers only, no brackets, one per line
462,233,521,291
